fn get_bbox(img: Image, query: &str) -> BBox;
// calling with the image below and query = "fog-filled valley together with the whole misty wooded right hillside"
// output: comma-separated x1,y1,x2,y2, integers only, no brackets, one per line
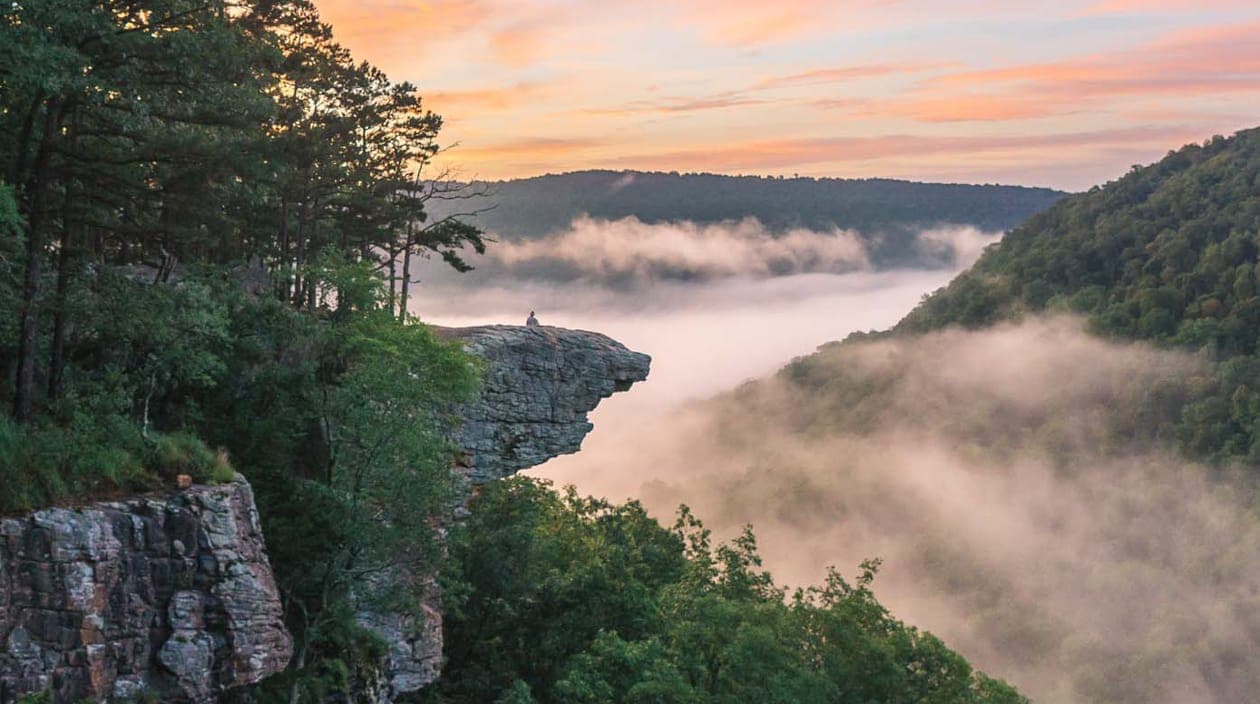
415,132,1260,704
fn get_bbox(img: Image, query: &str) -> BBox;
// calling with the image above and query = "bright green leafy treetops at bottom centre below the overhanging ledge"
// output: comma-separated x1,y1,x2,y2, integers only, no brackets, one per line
425,477,1024,704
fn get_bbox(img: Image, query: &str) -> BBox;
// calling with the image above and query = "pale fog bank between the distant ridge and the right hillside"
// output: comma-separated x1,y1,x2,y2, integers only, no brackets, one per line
410,218,999,408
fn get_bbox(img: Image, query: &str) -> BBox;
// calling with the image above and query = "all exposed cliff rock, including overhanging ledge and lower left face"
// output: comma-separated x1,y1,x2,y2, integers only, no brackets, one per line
0,326,650,704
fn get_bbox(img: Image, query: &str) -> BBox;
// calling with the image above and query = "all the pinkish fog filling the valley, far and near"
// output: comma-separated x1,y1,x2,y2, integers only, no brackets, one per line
411,205,1260,704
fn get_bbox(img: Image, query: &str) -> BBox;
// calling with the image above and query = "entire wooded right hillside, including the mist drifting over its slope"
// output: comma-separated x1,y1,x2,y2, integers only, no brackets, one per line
542,131,1260,704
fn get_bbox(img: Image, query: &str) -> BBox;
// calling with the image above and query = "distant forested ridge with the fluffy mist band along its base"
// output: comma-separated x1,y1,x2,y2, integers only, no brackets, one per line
431,171,1065,282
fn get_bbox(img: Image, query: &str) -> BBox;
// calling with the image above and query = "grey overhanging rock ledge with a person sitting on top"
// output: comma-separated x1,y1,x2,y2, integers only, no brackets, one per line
438,325,651,484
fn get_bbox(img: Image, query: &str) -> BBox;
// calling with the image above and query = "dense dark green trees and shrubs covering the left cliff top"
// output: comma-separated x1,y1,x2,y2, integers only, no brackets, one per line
0,0,481,700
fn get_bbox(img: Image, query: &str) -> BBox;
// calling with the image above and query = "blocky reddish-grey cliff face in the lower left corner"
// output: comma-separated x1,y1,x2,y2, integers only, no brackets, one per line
0,479,292,704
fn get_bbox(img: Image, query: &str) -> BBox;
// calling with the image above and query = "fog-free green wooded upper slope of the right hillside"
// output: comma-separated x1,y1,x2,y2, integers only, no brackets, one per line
896,128,1260,463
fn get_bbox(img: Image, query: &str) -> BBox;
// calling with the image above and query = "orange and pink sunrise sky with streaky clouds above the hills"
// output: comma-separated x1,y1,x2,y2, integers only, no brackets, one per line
316,0,1260,190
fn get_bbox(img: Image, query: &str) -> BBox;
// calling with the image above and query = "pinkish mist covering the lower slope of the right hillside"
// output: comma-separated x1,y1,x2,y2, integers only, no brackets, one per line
541,320,1260,704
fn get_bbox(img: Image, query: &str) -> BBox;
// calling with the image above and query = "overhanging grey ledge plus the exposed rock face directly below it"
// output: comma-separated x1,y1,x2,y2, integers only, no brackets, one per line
359,325,651,703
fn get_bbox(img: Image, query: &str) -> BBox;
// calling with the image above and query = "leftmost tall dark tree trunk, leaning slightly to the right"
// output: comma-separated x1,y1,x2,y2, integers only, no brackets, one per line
13,98,62,423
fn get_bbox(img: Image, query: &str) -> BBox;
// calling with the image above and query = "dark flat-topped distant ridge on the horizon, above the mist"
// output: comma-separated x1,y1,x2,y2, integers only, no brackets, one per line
428,171,1063,266
